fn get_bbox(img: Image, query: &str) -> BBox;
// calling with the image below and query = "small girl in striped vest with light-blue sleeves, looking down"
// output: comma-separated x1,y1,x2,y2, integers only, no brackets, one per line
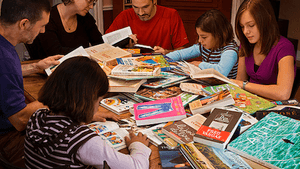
166,9,238,78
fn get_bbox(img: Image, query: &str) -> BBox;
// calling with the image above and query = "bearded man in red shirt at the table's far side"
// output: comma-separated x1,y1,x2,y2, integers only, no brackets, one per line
105,0,189,54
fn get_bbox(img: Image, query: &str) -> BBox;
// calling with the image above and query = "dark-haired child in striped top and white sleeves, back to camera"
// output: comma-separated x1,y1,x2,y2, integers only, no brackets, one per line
25,56,151,169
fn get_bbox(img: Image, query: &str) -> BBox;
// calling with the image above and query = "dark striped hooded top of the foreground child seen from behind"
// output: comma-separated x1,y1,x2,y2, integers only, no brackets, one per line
25,109,98,168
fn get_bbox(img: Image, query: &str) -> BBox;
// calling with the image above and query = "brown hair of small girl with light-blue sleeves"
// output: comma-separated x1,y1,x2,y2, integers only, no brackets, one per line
195,9,233,49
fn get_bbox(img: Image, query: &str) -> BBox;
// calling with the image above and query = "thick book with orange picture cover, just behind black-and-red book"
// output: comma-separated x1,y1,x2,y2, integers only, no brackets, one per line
189,90,234,114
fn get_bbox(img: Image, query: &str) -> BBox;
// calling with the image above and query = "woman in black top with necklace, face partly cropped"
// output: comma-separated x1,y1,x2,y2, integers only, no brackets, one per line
29,0,103,59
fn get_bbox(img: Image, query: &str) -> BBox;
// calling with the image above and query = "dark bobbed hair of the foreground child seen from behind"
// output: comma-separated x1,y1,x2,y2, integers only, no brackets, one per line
38,56,108,123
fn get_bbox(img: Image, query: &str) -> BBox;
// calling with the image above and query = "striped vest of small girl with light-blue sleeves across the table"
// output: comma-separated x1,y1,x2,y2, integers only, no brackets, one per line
199,41,238,79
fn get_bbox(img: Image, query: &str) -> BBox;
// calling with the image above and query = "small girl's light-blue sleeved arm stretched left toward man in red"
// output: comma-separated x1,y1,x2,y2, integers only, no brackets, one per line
166,44,201,61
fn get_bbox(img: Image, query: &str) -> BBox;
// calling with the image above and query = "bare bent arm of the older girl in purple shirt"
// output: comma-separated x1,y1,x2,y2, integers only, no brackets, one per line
234,55,295,100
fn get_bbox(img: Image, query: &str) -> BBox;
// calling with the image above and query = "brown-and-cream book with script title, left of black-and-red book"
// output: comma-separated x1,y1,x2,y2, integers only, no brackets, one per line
162,114,206,144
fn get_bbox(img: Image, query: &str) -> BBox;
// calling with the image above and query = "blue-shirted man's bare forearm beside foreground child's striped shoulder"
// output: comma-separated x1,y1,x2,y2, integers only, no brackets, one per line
8,101,46,131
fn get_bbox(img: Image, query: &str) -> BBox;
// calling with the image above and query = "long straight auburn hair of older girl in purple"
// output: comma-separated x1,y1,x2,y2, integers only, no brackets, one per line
235,0,280,56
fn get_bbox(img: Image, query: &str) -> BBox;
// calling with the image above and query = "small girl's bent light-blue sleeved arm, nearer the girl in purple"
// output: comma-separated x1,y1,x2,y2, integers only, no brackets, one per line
199,50,237,77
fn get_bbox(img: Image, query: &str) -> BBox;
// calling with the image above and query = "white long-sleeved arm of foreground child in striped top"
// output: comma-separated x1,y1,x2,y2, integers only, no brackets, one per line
77,137,151,169
